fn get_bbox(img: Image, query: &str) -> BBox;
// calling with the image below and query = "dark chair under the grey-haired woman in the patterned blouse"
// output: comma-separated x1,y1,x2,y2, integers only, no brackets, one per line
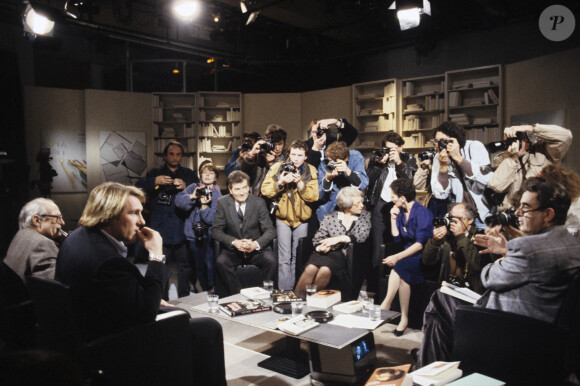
296,237,370,302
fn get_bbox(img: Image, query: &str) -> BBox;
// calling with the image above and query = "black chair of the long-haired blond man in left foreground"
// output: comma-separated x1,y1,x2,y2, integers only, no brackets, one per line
28,277,193,385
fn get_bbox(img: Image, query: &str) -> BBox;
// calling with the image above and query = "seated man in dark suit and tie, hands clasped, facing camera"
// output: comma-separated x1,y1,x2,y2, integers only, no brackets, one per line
211,170,278,295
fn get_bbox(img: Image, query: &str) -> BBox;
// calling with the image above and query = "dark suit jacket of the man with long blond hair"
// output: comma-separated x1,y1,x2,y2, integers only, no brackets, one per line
55,227,166,339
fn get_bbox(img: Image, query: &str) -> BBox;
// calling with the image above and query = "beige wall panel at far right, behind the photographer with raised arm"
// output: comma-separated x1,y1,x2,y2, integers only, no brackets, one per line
504,48,580,172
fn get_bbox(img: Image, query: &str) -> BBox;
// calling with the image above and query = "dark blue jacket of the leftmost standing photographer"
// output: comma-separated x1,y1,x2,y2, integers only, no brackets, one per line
136,165,199,244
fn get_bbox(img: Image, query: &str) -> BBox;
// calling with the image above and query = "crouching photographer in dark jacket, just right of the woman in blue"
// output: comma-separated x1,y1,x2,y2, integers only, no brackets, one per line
421,203,492,294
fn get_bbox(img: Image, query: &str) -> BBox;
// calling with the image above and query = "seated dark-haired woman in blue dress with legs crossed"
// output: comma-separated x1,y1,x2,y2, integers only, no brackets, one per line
381,178,433,336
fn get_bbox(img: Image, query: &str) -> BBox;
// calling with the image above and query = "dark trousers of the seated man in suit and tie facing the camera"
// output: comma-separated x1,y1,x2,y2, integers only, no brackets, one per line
215,248,278,296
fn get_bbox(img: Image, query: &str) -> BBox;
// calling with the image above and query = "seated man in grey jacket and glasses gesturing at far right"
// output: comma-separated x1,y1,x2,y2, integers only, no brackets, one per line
417,182,580,368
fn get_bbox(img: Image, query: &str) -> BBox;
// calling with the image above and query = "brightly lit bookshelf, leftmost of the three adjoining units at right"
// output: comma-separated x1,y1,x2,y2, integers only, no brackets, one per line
352,79,398,155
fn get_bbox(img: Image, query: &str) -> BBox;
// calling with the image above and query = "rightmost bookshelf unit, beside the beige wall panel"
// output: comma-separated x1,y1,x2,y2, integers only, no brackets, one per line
445,65,503,143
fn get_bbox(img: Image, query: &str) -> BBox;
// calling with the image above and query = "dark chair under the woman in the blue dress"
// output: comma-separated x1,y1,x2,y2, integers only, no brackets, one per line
375,244,441,330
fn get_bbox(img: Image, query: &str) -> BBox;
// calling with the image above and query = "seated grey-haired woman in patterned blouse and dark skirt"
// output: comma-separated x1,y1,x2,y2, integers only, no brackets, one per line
296,186,371,291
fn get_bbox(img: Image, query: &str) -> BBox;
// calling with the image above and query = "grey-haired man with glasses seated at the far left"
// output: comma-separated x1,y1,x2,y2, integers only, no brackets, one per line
4,198,64,283
